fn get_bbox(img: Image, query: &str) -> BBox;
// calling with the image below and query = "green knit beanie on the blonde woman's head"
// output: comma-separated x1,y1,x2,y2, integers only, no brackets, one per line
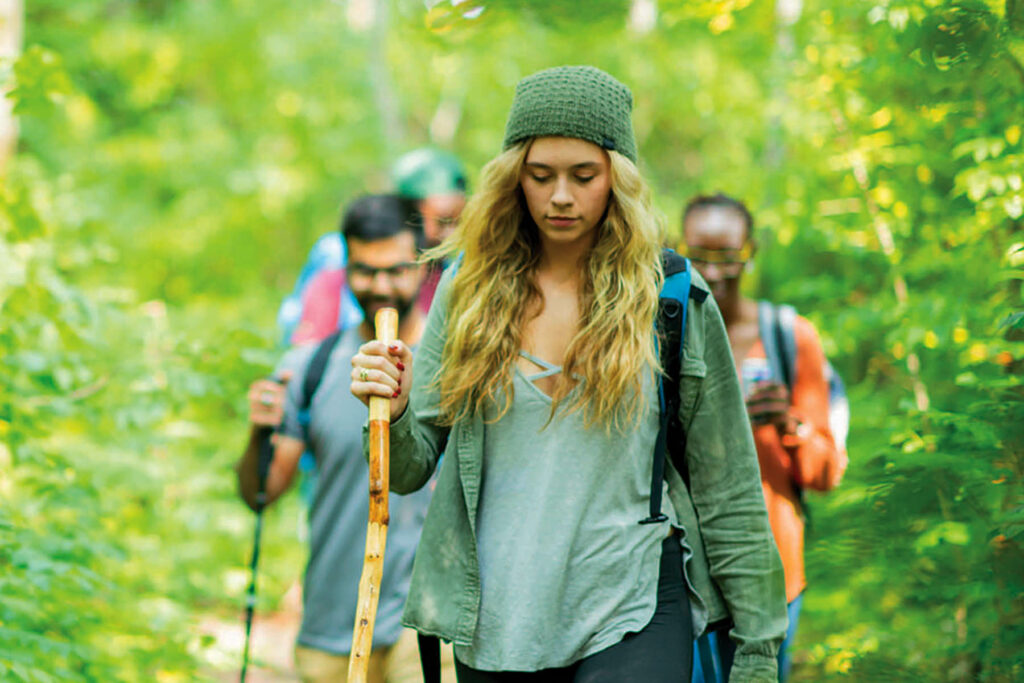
503,67,637,164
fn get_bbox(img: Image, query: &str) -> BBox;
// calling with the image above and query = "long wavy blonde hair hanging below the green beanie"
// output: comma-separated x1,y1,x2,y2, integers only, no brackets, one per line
428,140,664,432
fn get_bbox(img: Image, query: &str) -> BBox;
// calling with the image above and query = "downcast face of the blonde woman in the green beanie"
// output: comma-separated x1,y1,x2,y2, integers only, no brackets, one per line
519,137,611,246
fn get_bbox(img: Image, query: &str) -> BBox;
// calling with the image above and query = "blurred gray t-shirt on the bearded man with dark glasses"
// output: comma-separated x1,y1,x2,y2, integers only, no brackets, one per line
281,329,430,654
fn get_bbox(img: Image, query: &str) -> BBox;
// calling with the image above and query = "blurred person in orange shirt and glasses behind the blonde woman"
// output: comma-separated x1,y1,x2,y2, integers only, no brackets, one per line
683,193,847,681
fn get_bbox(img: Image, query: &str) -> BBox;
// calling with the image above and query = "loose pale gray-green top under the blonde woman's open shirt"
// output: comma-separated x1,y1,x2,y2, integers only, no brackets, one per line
456,367,678,671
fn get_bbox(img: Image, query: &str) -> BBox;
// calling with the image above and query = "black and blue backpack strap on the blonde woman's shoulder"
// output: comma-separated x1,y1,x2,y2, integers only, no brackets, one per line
640,249,708,524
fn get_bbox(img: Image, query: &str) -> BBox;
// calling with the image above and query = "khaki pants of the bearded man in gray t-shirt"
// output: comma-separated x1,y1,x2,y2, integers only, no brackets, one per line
295,629,456,683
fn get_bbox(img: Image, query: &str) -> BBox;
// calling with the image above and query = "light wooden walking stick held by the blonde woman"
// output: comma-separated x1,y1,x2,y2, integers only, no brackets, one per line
348,308,398,683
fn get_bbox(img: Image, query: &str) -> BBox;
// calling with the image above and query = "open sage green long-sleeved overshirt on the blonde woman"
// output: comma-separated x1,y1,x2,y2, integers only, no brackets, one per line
365,269,786,682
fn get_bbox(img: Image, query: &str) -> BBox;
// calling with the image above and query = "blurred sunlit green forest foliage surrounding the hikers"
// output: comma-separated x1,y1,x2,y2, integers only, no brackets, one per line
0,0,1024,681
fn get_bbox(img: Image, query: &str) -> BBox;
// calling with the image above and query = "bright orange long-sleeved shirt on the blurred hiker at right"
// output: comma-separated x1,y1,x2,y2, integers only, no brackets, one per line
737,315,845,601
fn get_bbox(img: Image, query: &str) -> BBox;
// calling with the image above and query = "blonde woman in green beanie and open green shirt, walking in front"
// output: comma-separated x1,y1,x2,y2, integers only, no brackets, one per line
351,67,785,683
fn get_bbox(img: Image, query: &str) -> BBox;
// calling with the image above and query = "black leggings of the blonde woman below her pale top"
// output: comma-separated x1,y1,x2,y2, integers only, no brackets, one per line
455,537,693,683
